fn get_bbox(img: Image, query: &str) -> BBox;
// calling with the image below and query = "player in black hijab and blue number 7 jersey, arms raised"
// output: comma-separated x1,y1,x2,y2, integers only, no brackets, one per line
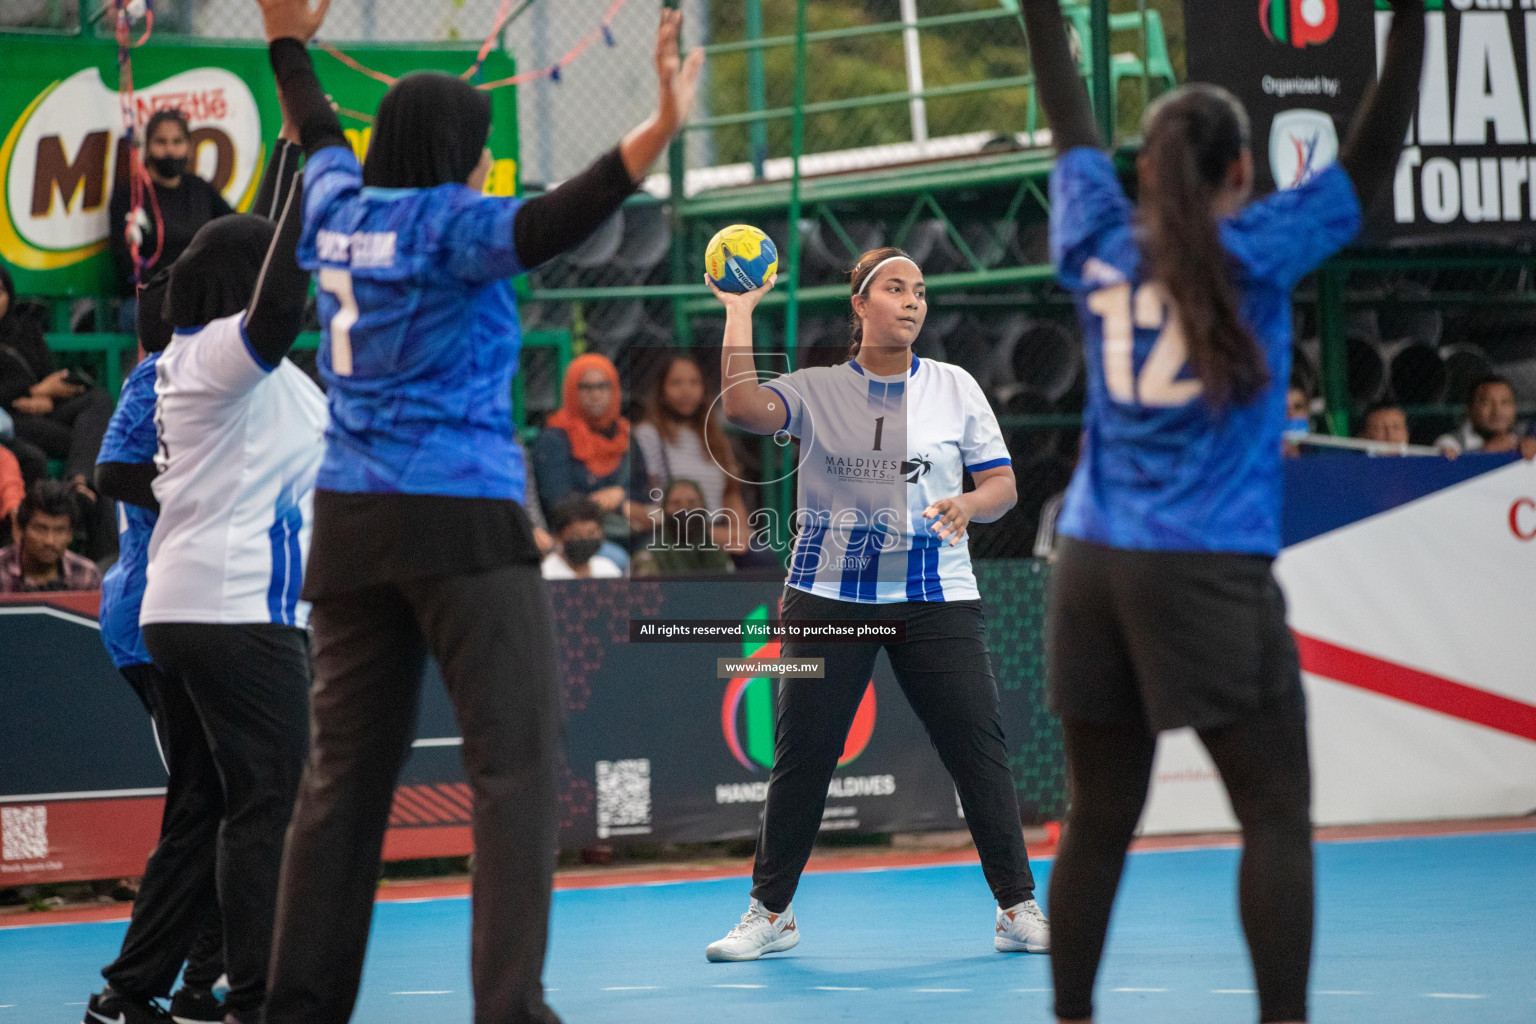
261,0,702,1024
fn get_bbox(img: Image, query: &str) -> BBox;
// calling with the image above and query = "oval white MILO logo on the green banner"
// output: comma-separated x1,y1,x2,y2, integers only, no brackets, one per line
0,68,263,270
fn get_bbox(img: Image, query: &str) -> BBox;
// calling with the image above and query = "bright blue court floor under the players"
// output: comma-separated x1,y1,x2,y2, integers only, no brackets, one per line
0,832,1536,1024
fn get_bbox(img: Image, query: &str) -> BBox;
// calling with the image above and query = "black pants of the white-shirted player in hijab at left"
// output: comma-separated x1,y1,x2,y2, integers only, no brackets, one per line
142,623,309,1024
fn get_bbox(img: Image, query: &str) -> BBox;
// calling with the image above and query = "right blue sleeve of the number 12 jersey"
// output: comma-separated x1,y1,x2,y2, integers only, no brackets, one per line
1223,164,1361,292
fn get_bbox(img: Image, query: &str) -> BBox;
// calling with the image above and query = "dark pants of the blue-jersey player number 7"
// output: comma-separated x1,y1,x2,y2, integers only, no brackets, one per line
266,565,561,1024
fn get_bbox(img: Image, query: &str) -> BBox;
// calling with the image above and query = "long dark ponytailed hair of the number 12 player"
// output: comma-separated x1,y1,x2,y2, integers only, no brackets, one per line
1140,86,1269,408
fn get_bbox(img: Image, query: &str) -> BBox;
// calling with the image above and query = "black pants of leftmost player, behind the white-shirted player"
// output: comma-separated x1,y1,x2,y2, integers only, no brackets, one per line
101,665,224,999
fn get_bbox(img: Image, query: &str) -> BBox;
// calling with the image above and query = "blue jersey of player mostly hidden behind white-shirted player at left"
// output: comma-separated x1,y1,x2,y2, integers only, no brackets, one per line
97,352,160,668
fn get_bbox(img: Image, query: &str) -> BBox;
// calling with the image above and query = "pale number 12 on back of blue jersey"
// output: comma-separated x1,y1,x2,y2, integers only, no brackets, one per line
1087,282,1201,408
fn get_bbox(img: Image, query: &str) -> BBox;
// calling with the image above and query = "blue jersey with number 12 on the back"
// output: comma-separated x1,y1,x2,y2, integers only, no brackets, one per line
1051,149,1361,556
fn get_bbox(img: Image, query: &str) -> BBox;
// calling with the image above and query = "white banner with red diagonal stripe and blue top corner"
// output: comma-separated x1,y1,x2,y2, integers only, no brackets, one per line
1143,456,1536,832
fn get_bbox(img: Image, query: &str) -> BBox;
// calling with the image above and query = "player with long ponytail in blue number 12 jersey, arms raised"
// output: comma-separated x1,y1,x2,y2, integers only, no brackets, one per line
1023,0,1424,1022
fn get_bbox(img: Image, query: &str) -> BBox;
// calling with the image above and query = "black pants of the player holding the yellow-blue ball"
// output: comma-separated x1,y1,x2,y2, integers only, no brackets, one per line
753,588,1035,913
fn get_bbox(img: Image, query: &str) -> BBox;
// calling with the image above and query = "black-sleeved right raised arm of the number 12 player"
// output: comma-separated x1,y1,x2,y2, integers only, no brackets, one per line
1339,0,1424,210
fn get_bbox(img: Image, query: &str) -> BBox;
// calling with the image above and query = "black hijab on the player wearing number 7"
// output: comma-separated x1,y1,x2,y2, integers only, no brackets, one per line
362,71,490,189
